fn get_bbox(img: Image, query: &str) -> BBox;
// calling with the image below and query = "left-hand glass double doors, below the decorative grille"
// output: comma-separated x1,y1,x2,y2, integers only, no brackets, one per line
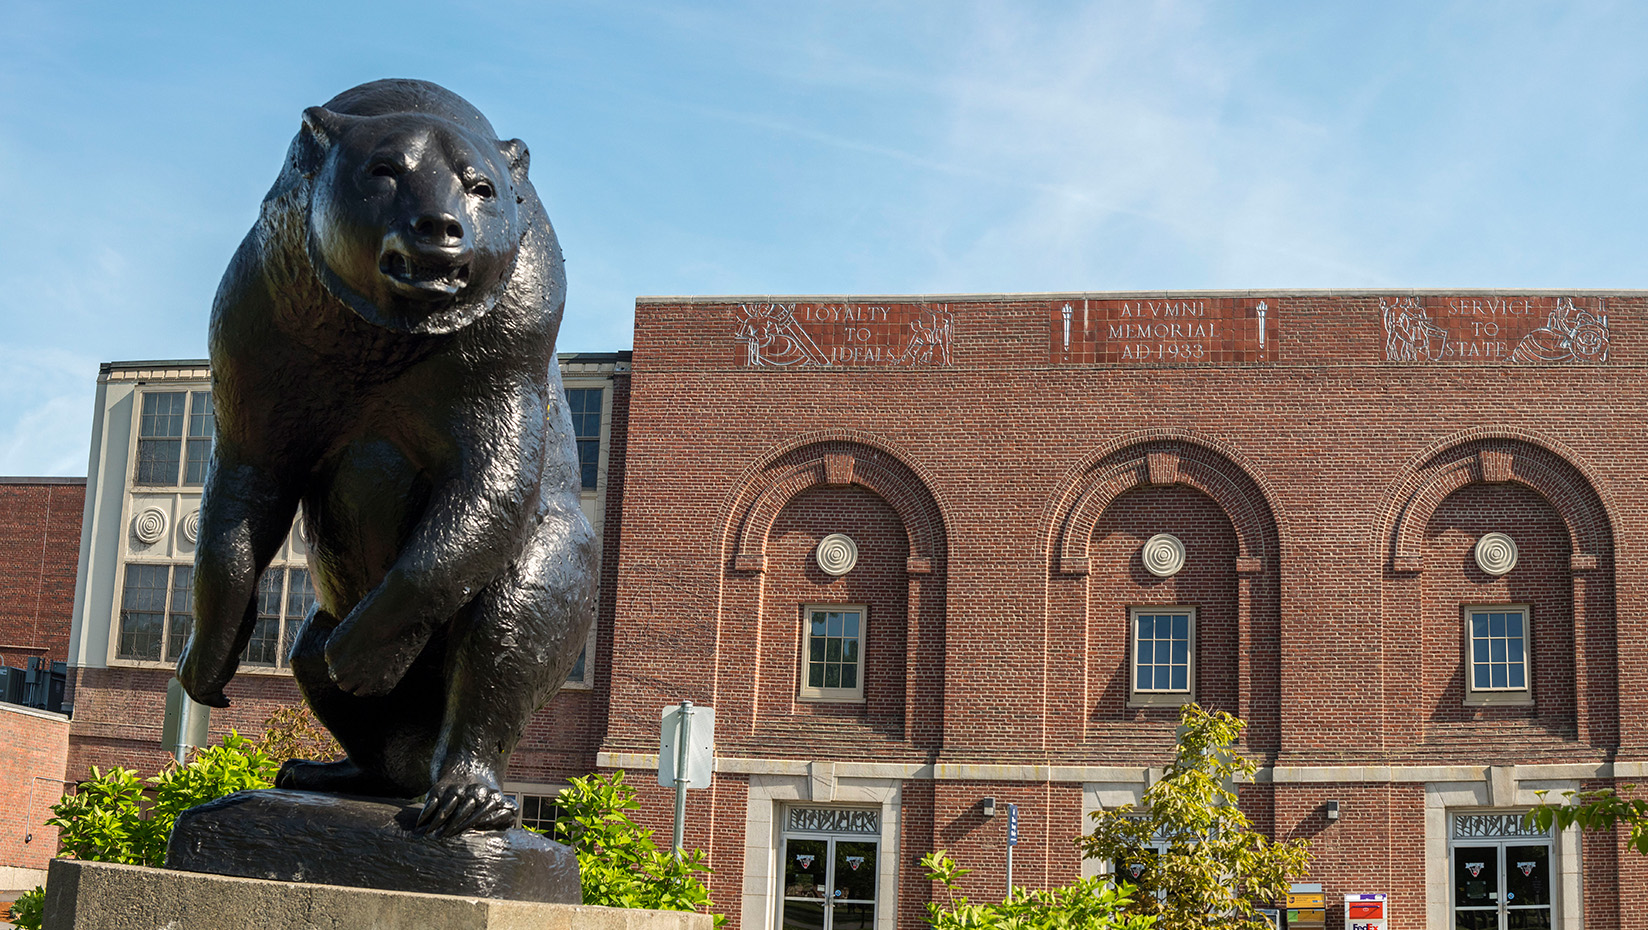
783,836,878,930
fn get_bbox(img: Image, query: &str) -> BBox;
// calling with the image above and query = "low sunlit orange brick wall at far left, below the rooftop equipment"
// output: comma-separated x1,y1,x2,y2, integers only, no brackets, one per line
0,704,69,869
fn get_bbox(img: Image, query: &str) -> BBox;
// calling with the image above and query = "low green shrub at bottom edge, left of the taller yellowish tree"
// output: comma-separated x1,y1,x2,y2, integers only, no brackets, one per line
921,849,1157,930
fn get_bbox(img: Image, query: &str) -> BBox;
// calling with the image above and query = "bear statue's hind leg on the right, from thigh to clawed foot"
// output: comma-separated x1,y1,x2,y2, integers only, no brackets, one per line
419,505,595,836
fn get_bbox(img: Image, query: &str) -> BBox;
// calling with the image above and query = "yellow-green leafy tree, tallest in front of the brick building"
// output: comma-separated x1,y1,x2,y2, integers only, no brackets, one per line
1076,704,1310,930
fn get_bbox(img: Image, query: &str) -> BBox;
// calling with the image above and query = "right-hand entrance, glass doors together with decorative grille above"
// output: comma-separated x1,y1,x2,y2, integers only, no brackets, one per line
1449,811,1562,930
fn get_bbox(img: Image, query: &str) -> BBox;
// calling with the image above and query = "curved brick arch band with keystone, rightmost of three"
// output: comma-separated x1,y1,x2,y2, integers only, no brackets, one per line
1379,430,1613,572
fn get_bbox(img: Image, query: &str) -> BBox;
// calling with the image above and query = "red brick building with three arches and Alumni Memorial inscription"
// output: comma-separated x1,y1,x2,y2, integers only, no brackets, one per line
600,292,1648,930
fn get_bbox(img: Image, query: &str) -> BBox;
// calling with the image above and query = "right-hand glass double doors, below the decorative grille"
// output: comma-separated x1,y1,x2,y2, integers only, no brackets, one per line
1454,839,1554,930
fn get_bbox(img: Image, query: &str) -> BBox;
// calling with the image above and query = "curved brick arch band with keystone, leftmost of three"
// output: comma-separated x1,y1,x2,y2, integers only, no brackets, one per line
727,430,946,574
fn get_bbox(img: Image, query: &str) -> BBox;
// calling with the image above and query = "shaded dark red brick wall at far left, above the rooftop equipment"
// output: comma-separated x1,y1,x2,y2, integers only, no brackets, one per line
0,478,86,666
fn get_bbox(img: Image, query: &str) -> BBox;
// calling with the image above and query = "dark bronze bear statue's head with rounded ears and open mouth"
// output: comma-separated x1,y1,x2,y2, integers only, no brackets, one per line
298,107,536,333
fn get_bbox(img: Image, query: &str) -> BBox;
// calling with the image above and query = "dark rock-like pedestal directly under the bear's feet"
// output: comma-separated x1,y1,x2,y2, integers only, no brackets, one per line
166,790,583,904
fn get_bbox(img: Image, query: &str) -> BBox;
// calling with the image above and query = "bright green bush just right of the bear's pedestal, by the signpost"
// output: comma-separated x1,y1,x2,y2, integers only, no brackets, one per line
552,772,727,927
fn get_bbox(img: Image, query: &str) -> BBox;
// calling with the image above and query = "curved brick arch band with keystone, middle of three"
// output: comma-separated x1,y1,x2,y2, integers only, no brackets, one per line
1051,430,1280,574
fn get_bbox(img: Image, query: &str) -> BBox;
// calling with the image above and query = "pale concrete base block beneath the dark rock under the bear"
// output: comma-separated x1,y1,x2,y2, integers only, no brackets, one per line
46,859,714,930
